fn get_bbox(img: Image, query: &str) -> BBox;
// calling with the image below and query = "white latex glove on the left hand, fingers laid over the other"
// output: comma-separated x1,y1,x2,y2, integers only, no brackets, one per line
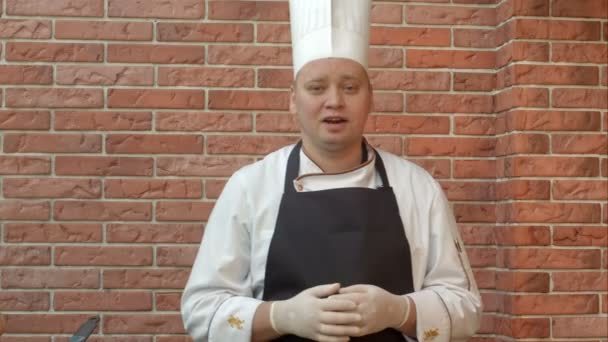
270,284,361,342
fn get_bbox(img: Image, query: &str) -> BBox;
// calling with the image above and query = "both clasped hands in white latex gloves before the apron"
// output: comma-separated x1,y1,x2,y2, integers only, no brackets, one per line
270,284,410,342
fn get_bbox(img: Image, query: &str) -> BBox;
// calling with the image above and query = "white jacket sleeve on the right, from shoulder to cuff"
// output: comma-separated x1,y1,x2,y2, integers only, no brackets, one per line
408,181,482,342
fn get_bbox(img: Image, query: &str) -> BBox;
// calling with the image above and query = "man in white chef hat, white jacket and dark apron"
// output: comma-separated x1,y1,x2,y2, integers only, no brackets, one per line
182,0,481,342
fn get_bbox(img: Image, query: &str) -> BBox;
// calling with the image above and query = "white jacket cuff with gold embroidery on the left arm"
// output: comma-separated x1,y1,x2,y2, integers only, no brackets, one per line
209,297,262,342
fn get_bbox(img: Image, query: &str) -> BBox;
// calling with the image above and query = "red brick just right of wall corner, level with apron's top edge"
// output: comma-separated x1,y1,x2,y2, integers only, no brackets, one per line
496,179,551,200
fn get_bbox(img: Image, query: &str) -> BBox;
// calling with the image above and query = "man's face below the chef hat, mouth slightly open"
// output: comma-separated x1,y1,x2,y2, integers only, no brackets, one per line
290,58,372,151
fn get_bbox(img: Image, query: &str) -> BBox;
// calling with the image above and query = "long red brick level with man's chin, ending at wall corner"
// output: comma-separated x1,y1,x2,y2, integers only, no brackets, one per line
406,138,496,157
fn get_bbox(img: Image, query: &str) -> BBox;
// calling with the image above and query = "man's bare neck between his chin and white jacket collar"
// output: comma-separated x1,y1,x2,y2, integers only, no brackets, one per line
302,140,362,173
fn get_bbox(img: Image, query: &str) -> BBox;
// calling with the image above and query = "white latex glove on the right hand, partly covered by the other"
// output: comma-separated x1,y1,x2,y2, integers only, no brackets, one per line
331,285,410,336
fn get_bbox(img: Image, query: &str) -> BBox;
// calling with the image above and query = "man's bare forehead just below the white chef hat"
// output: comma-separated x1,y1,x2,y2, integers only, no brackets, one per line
296,58,367,82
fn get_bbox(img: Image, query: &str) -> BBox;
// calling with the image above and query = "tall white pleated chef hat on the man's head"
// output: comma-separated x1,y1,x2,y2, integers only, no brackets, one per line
289,0,371,75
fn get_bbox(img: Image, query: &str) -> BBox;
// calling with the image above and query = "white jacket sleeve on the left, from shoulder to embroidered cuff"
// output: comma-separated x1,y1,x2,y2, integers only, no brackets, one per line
181,172,261,342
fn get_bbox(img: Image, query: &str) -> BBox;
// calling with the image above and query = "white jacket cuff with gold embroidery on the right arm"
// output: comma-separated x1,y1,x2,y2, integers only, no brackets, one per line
407,290,452,342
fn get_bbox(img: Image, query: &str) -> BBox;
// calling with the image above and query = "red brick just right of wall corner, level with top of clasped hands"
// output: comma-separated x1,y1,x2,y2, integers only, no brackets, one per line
496,271,551,293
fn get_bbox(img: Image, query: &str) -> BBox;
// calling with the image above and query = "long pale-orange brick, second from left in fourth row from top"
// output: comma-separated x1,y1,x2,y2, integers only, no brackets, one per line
56,65,154,86
